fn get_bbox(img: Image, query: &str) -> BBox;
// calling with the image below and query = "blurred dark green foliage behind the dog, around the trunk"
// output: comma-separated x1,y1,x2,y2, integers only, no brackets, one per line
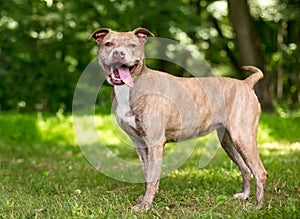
0,0,300,112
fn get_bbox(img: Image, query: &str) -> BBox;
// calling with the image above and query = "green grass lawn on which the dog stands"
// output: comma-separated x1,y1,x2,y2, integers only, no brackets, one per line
0,113,300,218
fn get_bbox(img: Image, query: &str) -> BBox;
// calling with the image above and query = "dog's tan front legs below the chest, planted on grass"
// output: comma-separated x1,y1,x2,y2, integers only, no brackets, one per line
133,142,164,211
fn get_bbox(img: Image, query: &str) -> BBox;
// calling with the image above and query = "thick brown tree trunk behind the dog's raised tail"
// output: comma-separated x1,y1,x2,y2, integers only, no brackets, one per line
227,0,272,111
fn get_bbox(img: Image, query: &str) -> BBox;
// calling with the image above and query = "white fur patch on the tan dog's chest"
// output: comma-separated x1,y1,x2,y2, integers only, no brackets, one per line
114,85,136,129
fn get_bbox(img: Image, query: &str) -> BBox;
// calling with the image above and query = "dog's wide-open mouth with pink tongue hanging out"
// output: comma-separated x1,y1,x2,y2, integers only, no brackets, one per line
104,62,138,87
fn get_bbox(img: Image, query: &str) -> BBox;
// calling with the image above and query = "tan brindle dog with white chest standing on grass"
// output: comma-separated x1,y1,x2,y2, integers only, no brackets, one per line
89,28,268,211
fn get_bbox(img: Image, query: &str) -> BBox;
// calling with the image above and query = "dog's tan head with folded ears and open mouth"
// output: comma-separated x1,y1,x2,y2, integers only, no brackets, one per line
90,28,153,87
